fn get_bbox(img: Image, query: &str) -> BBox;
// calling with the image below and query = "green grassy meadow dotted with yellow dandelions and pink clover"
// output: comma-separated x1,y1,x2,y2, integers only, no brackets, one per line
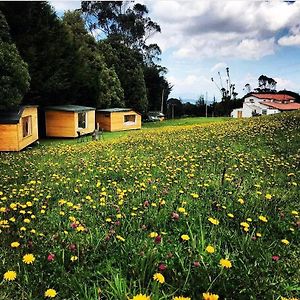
0,113,300,300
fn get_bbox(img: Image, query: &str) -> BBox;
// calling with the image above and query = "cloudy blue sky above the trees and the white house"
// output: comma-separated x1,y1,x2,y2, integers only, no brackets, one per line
50,0,300,102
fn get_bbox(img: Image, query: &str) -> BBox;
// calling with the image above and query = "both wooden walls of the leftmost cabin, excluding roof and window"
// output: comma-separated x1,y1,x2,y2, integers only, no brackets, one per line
0,107,38,151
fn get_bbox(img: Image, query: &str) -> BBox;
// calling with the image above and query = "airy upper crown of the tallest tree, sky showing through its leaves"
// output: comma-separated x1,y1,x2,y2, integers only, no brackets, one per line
81,1,161,63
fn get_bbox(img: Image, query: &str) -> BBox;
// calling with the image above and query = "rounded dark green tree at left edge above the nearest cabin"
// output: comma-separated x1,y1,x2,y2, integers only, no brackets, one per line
0,11,30,110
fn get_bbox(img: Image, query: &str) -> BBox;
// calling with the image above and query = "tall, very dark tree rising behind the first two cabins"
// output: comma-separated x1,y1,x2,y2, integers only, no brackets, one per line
0,1,76,104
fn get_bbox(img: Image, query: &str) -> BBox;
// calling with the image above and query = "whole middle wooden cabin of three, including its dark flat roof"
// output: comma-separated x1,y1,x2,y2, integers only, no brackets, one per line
45,105,96,138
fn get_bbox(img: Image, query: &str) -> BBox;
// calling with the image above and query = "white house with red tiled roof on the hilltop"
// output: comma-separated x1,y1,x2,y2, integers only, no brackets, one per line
230,93,300,118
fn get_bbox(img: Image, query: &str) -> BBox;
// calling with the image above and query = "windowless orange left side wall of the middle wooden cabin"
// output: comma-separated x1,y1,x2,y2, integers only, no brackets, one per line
45,111,77,137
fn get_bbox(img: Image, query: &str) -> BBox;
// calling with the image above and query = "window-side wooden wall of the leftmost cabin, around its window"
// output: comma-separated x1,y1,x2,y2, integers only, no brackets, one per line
18,107,39,150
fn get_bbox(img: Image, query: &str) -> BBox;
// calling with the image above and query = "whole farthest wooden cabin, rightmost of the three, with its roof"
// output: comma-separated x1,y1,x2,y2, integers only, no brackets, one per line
96,108,142,131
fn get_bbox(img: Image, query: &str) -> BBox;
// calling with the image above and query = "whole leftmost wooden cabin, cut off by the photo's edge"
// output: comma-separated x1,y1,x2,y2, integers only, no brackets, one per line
0,105,39,151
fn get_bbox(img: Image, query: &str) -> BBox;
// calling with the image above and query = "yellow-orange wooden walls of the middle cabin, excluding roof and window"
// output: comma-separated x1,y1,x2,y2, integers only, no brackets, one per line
45,111,95,138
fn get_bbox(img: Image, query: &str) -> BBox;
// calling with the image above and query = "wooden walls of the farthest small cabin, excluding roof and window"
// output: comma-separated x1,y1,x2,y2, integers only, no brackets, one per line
96,110,142,131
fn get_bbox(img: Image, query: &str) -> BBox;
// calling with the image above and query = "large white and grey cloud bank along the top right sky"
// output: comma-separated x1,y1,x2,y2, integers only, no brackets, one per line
145,0,300,60
